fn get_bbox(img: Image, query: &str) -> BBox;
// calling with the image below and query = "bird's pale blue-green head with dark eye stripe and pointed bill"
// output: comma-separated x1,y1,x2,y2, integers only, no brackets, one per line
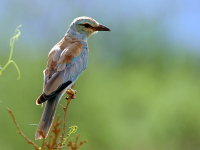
67,17,110,38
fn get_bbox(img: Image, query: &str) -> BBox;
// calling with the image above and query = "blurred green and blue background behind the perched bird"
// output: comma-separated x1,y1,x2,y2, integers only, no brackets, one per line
0,0,200,150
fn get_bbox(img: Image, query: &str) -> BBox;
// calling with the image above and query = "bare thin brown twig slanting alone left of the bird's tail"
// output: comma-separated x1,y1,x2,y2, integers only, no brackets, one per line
7,107,39,150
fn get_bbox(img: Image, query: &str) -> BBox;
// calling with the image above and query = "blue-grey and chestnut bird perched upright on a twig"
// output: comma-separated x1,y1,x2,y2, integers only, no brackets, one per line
35,16,110,140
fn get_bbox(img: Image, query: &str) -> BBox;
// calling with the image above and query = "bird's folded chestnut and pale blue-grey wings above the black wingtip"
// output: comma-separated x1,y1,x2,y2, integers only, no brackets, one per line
43,41,88,95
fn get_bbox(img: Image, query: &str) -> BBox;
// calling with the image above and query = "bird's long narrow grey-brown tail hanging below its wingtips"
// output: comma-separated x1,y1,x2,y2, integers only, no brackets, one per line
35,94,61,140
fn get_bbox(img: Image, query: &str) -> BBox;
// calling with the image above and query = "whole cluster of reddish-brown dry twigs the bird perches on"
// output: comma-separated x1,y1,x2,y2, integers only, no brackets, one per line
7,85,87,150
